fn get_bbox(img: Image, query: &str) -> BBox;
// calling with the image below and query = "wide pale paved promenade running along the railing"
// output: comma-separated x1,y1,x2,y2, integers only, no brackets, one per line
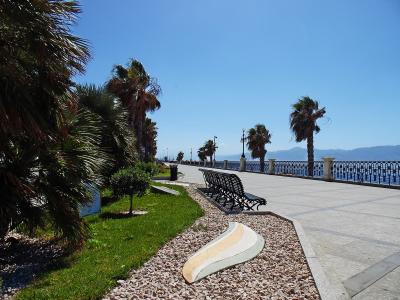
178,165,400,300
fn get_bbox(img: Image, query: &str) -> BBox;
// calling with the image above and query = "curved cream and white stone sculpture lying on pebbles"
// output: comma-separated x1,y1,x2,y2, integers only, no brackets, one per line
182,222,265,283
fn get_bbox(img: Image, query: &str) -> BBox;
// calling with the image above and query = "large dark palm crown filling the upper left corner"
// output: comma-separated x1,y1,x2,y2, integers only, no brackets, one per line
0,0,89,144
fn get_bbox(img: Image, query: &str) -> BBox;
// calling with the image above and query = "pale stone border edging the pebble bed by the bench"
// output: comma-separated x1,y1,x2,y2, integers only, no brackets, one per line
189,183,350,300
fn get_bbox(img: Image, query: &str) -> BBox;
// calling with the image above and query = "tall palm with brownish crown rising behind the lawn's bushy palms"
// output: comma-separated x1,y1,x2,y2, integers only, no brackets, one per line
107,59,161,157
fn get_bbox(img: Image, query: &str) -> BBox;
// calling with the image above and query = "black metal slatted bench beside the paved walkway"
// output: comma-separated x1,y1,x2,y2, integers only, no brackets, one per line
199,169,267,210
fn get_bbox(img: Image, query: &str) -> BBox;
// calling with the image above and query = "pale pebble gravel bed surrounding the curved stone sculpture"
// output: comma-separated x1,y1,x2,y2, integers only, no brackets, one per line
104,186,320,300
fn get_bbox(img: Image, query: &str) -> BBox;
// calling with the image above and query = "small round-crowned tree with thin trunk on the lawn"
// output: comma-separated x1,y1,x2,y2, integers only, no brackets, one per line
111,167,150,216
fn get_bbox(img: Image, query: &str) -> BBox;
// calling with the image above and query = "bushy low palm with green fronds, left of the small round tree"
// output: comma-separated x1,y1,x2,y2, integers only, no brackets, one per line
41,108,110,245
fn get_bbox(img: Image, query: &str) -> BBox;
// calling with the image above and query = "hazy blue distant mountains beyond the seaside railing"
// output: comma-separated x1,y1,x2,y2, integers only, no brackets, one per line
217,145,400,160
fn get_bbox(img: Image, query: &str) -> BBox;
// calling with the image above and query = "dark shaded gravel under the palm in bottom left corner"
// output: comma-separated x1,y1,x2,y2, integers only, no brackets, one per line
0,233,65,300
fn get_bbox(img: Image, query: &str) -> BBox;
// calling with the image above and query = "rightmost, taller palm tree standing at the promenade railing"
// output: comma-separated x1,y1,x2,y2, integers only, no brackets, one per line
290,96,326,176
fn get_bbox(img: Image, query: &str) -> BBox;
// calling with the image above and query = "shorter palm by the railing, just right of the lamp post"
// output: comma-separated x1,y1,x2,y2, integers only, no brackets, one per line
246,124,271,173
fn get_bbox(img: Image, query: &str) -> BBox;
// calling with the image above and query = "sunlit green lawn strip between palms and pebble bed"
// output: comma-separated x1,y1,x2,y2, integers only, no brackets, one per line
17,186,203,299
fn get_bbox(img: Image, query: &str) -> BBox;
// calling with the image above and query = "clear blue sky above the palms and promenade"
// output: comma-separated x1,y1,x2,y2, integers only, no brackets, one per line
74,0,400,158
